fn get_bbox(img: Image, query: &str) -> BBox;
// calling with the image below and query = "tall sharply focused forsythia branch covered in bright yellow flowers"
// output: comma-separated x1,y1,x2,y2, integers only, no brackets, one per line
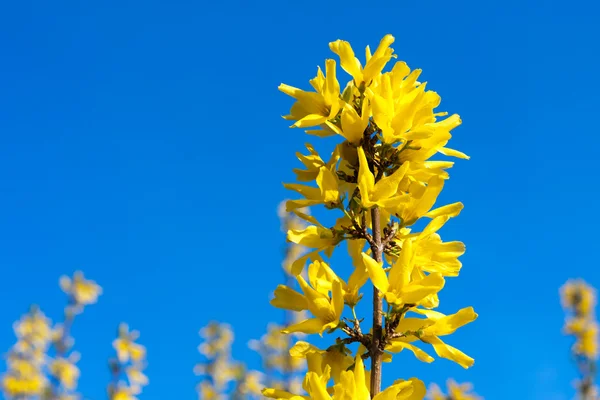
264,35,477,399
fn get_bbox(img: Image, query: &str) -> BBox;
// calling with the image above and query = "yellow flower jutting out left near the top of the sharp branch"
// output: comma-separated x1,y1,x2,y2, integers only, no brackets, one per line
279,60,341,128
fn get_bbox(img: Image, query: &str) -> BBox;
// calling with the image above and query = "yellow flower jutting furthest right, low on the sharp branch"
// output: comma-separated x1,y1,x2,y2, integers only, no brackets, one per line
386,307,477,368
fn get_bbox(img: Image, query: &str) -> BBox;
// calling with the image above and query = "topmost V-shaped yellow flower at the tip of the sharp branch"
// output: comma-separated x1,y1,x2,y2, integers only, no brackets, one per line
329,35,394,87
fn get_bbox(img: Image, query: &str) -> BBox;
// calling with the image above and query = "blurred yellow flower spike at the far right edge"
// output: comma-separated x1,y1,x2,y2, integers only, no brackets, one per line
560,280,598,400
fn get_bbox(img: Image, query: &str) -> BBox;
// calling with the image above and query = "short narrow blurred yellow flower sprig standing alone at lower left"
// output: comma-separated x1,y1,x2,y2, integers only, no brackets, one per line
108,323,148,400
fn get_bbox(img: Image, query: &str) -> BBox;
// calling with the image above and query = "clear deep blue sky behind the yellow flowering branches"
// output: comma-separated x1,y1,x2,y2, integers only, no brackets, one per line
0,0,600,400
